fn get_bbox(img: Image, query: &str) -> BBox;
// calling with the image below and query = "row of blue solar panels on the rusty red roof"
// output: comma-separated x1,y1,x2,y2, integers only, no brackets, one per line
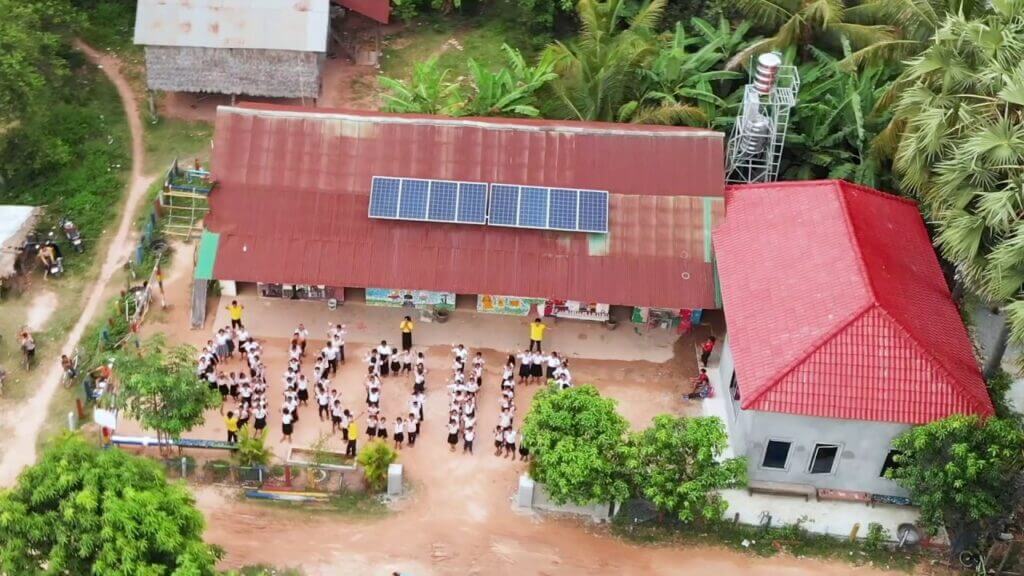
370,176,608,234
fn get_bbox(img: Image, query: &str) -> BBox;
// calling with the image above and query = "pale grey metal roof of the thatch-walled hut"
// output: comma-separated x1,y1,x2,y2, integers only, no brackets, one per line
135,0,323,52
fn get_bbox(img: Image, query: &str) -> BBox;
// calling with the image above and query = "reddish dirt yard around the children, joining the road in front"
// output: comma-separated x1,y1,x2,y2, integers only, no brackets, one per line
112,246,901,576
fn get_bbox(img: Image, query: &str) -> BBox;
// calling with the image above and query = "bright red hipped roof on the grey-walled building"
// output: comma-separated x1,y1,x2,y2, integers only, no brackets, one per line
714,180,992,424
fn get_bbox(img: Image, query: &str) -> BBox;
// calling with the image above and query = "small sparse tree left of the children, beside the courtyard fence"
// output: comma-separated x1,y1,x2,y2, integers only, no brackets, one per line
113,335,220,448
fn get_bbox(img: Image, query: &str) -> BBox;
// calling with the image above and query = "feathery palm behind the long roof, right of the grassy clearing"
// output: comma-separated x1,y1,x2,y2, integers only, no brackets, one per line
546,0,667,121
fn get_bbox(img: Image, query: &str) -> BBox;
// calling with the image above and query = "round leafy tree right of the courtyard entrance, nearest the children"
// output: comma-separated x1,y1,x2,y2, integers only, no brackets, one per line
522,385,630,504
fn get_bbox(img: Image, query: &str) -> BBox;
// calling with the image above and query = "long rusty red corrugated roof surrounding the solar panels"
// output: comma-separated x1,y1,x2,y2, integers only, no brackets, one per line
207,105,724,307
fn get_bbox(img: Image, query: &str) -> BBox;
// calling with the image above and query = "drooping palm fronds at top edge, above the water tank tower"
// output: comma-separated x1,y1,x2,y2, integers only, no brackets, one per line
729,0,894,69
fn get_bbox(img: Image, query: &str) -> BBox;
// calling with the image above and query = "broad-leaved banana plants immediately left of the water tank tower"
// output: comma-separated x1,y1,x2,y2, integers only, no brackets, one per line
620,18,750,128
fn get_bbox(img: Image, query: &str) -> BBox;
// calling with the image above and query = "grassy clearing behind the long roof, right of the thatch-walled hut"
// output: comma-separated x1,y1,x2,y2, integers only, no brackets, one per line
381,2,544,79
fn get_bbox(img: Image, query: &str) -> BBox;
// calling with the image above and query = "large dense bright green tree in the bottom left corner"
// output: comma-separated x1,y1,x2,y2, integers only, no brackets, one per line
0,436,218,576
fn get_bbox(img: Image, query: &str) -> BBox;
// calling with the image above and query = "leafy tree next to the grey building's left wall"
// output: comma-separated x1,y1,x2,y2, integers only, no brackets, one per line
626,414,746,523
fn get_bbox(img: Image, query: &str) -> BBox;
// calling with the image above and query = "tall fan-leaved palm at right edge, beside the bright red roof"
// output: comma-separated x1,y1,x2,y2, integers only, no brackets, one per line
893,0,1024,376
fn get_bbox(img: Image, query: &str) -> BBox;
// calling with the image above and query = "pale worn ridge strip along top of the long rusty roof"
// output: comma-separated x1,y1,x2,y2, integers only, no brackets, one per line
217,102,725,139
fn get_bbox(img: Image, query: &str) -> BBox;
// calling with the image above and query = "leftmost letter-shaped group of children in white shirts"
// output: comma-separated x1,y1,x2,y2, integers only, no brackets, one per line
196,321,269,442
